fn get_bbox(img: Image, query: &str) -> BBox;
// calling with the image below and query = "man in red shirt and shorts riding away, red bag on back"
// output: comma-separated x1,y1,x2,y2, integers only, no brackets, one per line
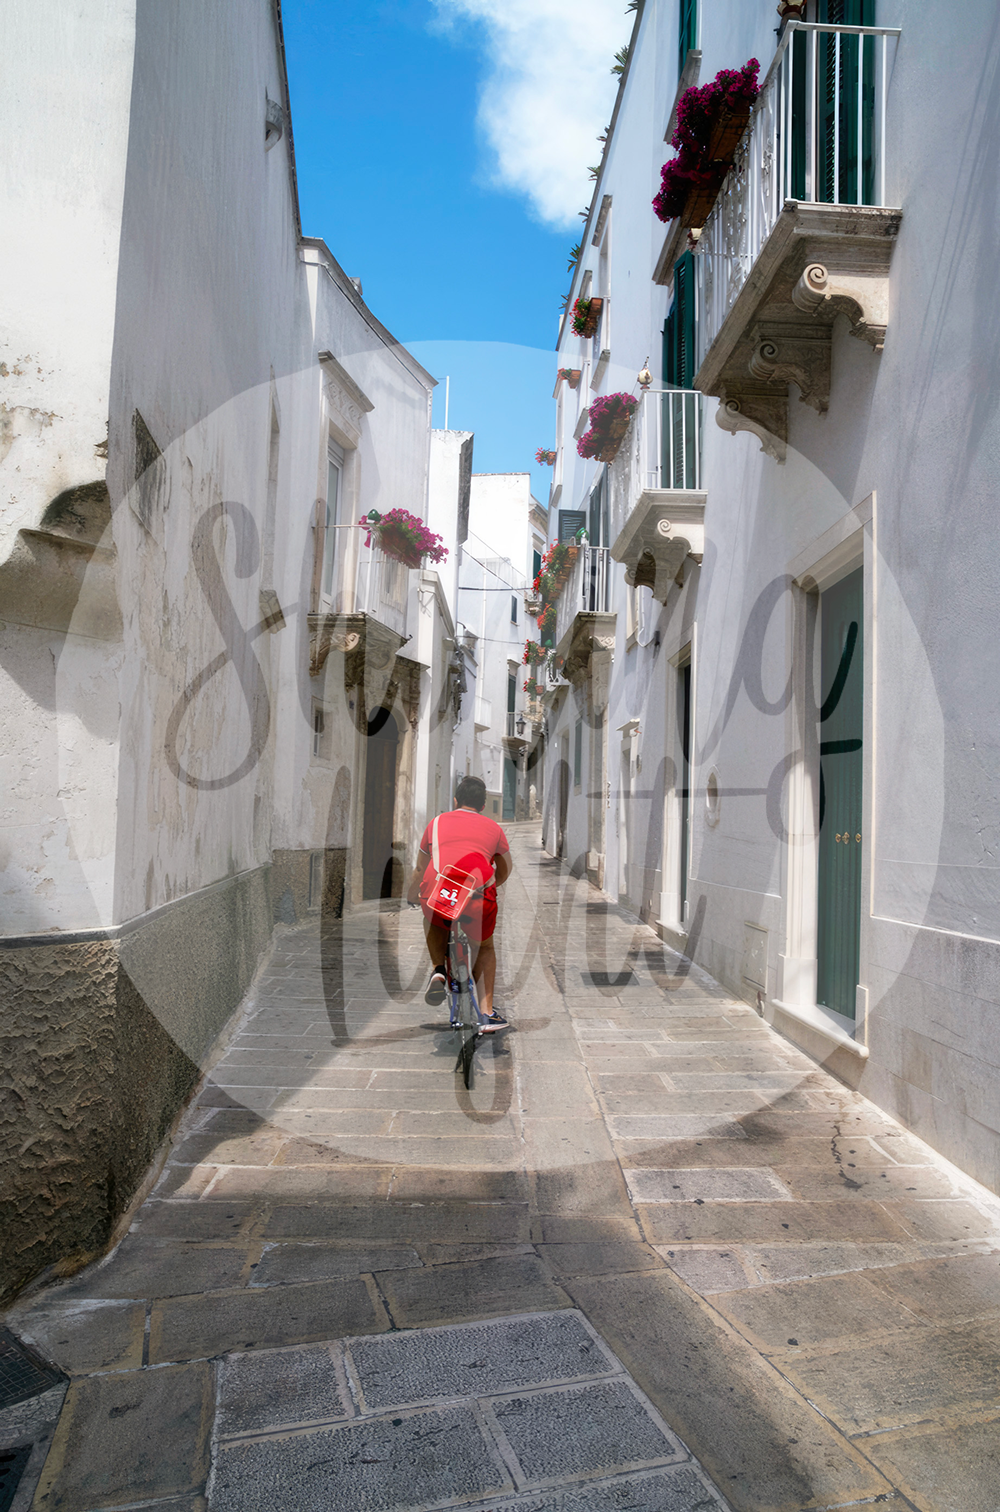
407,777,511,1034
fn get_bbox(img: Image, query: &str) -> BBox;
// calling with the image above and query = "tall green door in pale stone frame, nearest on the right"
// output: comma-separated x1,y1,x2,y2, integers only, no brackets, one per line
815,567,864,1019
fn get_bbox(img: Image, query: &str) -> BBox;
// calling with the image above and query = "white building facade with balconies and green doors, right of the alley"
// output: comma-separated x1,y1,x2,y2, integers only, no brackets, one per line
545,0,1000,1190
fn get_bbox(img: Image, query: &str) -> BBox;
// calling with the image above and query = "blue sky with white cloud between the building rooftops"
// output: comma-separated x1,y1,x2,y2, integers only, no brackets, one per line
283,0,629,500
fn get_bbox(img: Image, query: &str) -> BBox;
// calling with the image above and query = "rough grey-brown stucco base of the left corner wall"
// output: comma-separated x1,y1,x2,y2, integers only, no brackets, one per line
0,868,271,1303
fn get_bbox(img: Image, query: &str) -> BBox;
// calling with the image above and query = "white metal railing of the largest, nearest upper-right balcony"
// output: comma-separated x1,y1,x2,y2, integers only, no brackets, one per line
696,21,900,367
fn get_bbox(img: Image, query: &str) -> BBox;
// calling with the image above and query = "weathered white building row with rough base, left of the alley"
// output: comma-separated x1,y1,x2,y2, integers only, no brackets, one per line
0,0,467,1290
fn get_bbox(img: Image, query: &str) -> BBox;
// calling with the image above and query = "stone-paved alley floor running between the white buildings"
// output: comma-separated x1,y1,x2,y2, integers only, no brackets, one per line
0,826,1000,1512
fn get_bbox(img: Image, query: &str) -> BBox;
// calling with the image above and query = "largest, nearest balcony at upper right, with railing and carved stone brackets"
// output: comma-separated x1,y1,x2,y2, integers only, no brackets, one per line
694,21,902,461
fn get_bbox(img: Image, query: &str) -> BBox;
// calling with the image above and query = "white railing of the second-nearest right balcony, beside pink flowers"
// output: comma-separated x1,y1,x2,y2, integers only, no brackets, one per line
608,389,705,541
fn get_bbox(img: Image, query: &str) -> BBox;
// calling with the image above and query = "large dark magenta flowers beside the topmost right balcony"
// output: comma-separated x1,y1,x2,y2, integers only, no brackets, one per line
652,57,761,225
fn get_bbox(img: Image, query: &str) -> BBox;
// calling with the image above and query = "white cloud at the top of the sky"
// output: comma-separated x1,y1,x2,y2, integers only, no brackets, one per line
433,0,632,227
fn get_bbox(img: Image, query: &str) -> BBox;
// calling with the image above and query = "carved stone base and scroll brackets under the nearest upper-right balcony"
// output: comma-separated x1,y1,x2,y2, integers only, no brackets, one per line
694,200,902,463
